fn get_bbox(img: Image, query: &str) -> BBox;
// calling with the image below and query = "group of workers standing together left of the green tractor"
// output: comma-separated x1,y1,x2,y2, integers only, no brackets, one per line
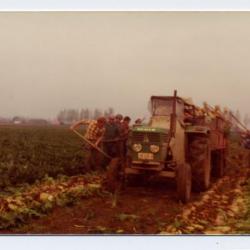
70,114,131,171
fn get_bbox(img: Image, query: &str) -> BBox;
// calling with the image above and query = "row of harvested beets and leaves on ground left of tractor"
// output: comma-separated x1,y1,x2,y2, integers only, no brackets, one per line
0,175,101,229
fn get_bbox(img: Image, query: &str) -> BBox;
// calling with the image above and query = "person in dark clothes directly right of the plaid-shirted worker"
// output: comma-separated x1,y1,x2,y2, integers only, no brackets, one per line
103,115,120,157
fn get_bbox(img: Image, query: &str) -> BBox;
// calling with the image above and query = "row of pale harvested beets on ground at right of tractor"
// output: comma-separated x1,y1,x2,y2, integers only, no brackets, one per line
161,170,248,234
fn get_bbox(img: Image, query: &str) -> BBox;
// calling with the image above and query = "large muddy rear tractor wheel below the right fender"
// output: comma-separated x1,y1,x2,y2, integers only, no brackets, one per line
189,137,211,191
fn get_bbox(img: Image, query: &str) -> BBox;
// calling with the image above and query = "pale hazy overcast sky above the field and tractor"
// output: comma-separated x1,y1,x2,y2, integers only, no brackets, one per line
0,12,250,121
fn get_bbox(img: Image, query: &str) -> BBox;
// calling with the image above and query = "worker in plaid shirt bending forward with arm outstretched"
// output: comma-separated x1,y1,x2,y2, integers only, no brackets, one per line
70,117,106,170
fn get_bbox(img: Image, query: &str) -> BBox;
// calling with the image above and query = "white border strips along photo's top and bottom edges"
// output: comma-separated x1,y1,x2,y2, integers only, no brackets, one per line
0,0,250,250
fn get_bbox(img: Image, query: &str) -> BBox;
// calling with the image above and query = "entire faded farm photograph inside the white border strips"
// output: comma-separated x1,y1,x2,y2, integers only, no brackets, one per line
0,11,250,235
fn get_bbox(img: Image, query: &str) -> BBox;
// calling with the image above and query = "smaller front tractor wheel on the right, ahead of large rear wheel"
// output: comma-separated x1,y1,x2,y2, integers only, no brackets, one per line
176,163,192,203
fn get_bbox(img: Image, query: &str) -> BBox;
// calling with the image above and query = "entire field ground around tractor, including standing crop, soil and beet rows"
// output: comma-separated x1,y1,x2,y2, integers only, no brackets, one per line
0,126,250,234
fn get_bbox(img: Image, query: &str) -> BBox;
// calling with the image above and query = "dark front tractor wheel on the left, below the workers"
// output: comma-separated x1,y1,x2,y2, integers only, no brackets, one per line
103,158,122,192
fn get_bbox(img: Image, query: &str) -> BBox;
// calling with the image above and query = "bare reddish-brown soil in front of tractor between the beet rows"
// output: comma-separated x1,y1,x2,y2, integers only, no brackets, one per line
0,181,201,234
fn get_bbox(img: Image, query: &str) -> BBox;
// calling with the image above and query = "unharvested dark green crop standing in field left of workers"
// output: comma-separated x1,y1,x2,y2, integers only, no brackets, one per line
0,126,87,187
